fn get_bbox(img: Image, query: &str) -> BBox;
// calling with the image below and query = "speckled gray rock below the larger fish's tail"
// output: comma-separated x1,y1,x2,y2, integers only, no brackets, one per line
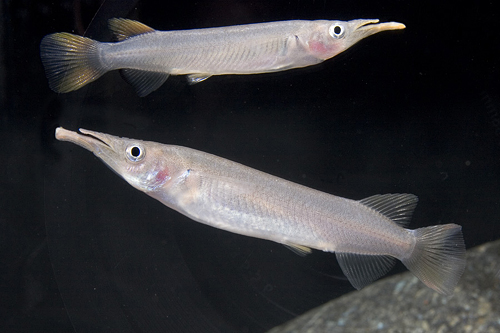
269,240,500,333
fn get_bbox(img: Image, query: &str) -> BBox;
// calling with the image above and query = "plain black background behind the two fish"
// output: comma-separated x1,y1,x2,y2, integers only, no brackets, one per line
0,0,500,332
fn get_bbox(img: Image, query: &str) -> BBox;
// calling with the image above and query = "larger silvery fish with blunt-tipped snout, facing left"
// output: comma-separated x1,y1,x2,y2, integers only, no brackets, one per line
56,127,465,295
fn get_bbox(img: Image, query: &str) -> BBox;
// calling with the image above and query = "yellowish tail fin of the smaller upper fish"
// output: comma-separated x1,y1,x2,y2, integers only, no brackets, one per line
40,32,107,93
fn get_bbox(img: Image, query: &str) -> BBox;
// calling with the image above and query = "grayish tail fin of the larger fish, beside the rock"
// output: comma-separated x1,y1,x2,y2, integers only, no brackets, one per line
402,224,465,295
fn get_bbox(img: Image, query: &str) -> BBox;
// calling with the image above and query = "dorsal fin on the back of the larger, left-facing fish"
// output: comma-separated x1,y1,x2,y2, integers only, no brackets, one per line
359,193,418,227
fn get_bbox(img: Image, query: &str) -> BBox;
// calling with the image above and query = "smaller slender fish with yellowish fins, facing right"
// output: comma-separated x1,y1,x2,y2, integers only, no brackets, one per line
40,18,405,96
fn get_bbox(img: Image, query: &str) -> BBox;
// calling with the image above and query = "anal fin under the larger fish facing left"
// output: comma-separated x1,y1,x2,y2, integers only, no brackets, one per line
335,252,396,290
